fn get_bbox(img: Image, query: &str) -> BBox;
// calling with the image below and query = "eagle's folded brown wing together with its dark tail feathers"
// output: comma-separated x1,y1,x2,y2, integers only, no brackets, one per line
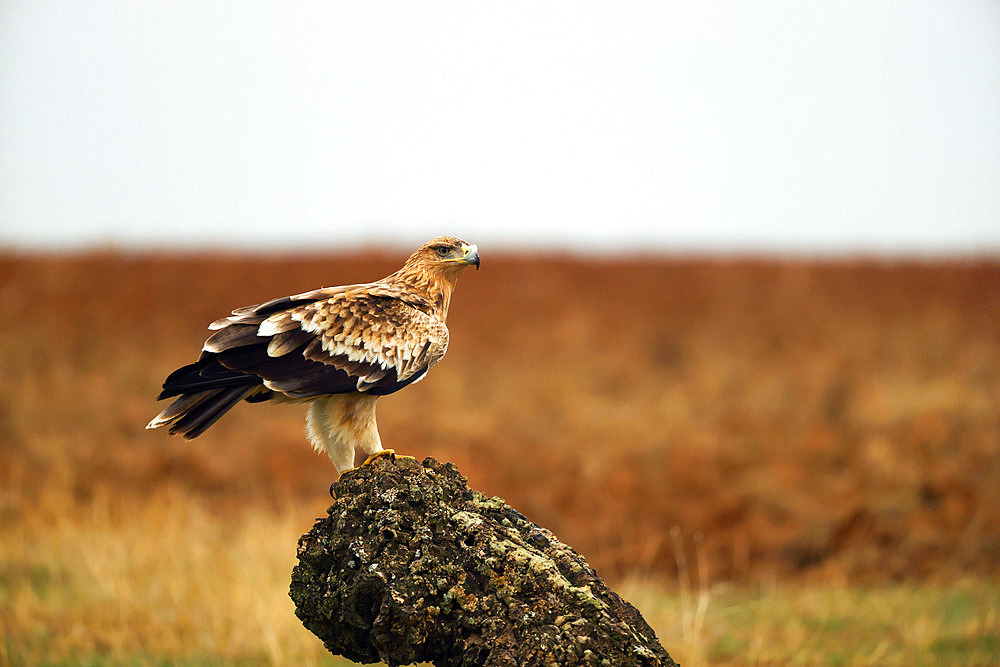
149,283,448,438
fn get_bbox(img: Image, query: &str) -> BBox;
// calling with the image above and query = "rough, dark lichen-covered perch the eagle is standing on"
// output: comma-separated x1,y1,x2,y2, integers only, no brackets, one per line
290,457,675,667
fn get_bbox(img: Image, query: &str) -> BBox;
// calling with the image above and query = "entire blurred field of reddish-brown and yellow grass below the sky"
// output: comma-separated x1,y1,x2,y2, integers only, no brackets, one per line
0,249,1000,665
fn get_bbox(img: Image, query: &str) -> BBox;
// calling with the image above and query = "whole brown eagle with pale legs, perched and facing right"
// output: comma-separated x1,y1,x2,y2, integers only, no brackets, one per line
146,236,479,474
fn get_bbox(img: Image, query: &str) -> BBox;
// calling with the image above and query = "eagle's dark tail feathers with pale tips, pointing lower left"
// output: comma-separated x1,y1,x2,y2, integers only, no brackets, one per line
146,355,270,440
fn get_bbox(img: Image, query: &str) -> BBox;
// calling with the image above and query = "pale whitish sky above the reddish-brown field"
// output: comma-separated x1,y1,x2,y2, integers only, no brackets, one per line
0,0,1000,254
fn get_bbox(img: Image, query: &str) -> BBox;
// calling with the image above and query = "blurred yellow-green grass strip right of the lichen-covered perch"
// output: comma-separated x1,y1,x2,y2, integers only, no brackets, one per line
622,580,1000,667
